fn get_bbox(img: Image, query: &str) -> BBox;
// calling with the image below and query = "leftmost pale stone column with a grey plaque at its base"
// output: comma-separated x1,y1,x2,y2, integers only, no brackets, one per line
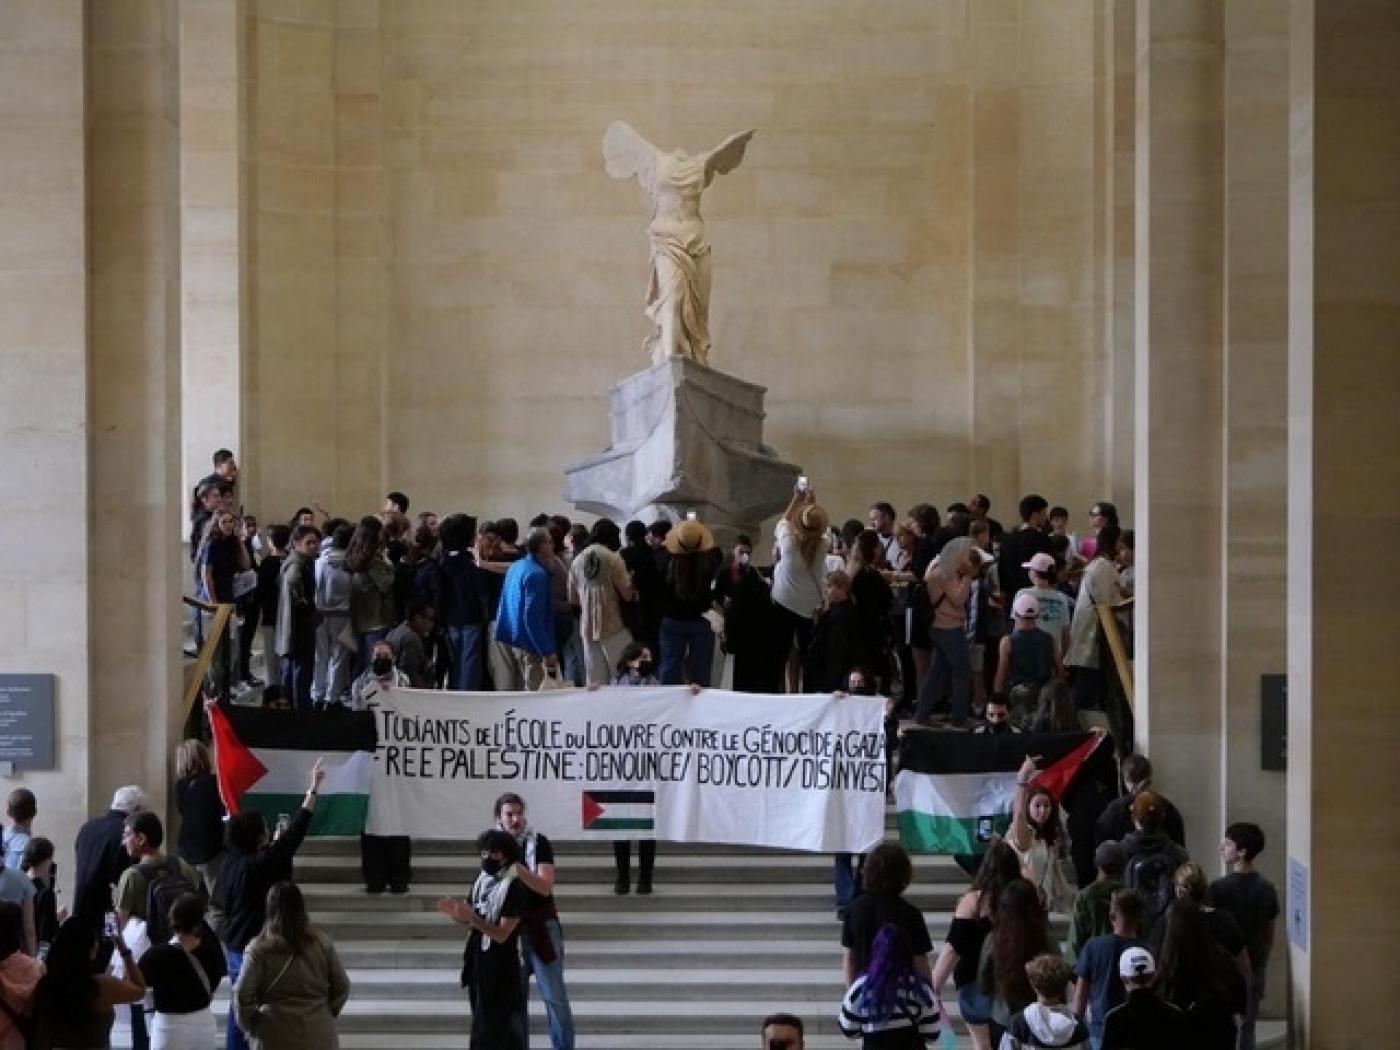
0,0,91,874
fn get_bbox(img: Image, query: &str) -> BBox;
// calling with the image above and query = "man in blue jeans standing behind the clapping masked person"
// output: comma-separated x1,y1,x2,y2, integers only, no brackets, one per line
496,791,574,1050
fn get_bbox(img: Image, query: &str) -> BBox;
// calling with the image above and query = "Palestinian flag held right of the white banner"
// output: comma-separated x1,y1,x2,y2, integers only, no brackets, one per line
895,732,1113,854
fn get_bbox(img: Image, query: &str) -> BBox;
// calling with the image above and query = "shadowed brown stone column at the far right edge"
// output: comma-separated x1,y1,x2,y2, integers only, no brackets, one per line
1280,0,1400,1050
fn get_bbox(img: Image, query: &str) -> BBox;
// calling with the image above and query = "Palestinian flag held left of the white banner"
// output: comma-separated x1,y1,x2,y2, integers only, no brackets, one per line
209,704,377,834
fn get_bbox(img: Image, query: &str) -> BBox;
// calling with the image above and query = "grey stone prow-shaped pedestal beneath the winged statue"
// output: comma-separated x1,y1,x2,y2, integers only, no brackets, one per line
564,357,801,542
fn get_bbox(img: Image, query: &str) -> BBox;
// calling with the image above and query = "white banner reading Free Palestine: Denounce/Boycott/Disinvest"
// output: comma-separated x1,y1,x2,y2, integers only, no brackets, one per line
367,686,885,853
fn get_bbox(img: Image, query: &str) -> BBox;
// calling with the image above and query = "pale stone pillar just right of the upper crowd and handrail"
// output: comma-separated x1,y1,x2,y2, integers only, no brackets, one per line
1134,0,1224,873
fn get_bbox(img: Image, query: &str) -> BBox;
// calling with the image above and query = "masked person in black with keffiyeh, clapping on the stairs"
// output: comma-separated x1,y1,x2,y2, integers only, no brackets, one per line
438,827,529,1050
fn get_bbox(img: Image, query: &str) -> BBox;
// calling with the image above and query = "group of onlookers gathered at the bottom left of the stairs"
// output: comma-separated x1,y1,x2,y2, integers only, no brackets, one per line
0,761,349,1050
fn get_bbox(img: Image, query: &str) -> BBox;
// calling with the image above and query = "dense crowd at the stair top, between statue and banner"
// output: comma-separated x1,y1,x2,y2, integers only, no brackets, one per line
190,449,1134,728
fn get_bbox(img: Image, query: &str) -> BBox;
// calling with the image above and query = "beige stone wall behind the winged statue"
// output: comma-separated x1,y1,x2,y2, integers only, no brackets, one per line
242,0,1113,519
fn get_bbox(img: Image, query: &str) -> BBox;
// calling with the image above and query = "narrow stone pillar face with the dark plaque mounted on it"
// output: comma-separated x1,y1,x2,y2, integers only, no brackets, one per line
1200,0,1288,1015
